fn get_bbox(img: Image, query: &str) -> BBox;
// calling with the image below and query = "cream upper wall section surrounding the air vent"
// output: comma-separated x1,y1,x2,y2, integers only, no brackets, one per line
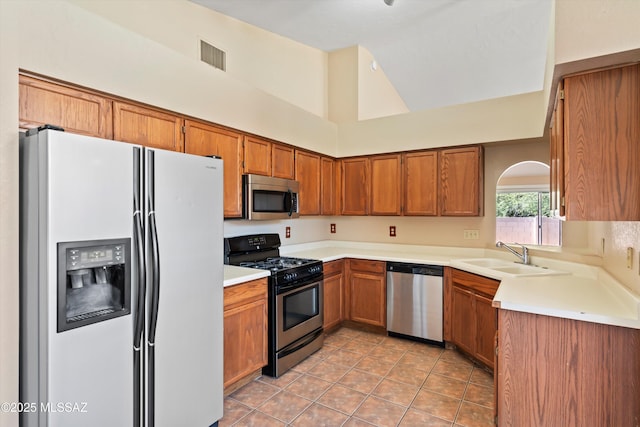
71,0,328,119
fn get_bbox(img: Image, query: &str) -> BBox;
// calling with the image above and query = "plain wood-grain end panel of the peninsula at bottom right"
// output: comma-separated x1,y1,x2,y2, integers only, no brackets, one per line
496,310,640,427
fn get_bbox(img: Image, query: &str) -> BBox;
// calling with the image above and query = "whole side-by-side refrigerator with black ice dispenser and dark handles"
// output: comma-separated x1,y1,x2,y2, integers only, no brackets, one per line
17,129,223,427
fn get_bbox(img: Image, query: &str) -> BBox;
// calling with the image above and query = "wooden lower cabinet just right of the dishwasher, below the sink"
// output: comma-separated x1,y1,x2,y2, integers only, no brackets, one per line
445,269,500,369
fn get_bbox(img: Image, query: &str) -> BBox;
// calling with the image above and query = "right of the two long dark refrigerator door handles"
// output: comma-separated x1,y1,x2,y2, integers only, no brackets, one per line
146,150,160,427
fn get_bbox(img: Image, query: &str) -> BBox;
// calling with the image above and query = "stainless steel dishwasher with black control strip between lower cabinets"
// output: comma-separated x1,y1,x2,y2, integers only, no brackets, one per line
387,262,444,345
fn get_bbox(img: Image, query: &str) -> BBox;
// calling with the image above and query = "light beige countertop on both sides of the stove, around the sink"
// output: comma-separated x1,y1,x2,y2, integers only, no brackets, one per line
224,240,640,329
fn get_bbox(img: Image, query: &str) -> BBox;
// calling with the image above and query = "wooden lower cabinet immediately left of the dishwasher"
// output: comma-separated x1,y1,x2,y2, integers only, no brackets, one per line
347,259,387,328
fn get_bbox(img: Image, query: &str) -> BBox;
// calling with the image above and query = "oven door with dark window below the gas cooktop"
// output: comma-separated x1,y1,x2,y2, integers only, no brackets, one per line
275,279,323,350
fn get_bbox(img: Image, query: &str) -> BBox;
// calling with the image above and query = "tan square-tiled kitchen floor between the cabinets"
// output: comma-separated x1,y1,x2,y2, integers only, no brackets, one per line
219,327,494,427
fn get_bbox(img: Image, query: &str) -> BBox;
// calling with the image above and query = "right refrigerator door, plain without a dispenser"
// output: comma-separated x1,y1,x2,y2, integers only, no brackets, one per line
145,150,223,427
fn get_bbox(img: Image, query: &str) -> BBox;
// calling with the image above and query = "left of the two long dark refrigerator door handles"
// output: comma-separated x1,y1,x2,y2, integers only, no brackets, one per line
133,147,147,427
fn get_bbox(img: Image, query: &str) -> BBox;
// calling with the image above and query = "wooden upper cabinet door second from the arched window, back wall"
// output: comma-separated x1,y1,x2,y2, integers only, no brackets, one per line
402,150,438,215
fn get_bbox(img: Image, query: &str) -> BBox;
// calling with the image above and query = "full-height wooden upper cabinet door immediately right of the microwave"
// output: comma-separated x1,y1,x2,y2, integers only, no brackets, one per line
295,150,320,215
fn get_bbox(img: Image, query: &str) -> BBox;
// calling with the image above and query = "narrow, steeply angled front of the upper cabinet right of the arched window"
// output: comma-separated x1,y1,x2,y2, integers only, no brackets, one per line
549,81,565,217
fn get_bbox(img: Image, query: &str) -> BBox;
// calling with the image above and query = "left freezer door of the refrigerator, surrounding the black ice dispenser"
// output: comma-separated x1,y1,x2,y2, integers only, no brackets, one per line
21,131,133,427
